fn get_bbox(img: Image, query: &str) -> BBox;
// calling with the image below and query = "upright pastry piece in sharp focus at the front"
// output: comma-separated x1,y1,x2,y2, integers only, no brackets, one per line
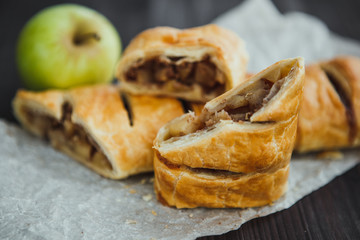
154,58,304,208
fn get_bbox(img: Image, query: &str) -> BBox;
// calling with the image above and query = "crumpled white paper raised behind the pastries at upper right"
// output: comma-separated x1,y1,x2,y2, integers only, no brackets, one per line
214,0,360,73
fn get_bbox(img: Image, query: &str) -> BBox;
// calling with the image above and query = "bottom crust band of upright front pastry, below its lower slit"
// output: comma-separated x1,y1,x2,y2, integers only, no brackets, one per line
154,154,289,208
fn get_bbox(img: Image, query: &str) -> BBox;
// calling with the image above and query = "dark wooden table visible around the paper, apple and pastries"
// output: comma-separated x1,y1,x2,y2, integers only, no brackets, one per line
0,0,360,239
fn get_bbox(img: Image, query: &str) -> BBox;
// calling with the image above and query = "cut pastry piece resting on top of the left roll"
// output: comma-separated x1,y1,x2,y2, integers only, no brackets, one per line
116,25,248,102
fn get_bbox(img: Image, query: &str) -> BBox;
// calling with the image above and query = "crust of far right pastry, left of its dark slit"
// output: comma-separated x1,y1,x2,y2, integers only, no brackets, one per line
295,64,349,152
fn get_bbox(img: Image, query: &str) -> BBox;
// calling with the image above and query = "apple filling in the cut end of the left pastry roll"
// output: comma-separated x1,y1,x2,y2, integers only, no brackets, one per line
23,104,112,171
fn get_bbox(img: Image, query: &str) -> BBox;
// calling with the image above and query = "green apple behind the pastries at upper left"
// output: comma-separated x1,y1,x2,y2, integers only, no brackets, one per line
16,4,121,90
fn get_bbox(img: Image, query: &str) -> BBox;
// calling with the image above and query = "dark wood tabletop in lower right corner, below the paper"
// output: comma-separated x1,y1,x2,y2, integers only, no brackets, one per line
198,164,360,240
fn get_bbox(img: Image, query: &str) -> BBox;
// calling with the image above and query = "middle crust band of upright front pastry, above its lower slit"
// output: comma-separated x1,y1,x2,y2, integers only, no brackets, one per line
156,114,297,173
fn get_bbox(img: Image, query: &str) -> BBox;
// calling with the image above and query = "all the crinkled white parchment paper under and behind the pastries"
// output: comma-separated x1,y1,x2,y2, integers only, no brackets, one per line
0,0,360,239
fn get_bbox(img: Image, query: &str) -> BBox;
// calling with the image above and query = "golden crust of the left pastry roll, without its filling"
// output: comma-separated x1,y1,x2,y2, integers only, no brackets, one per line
13,85,183,179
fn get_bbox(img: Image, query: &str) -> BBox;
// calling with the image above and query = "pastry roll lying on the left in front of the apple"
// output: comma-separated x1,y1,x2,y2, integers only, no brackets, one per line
13,85,184,179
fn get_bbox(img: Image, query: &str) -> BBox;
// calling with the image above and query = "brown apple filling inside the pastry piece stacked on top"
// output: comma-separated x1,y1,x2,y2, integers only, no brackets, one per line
125,56,225,96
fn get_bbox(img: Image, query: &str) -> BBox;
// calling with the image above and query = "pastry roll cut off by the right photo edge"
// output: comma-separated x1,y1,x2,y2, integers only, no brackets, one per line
295,56,360,152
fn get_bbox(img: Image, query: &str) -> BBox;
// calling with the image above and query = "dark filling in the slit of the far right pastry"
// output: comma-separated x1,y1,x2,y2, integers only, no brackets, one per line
323,69,357,143
